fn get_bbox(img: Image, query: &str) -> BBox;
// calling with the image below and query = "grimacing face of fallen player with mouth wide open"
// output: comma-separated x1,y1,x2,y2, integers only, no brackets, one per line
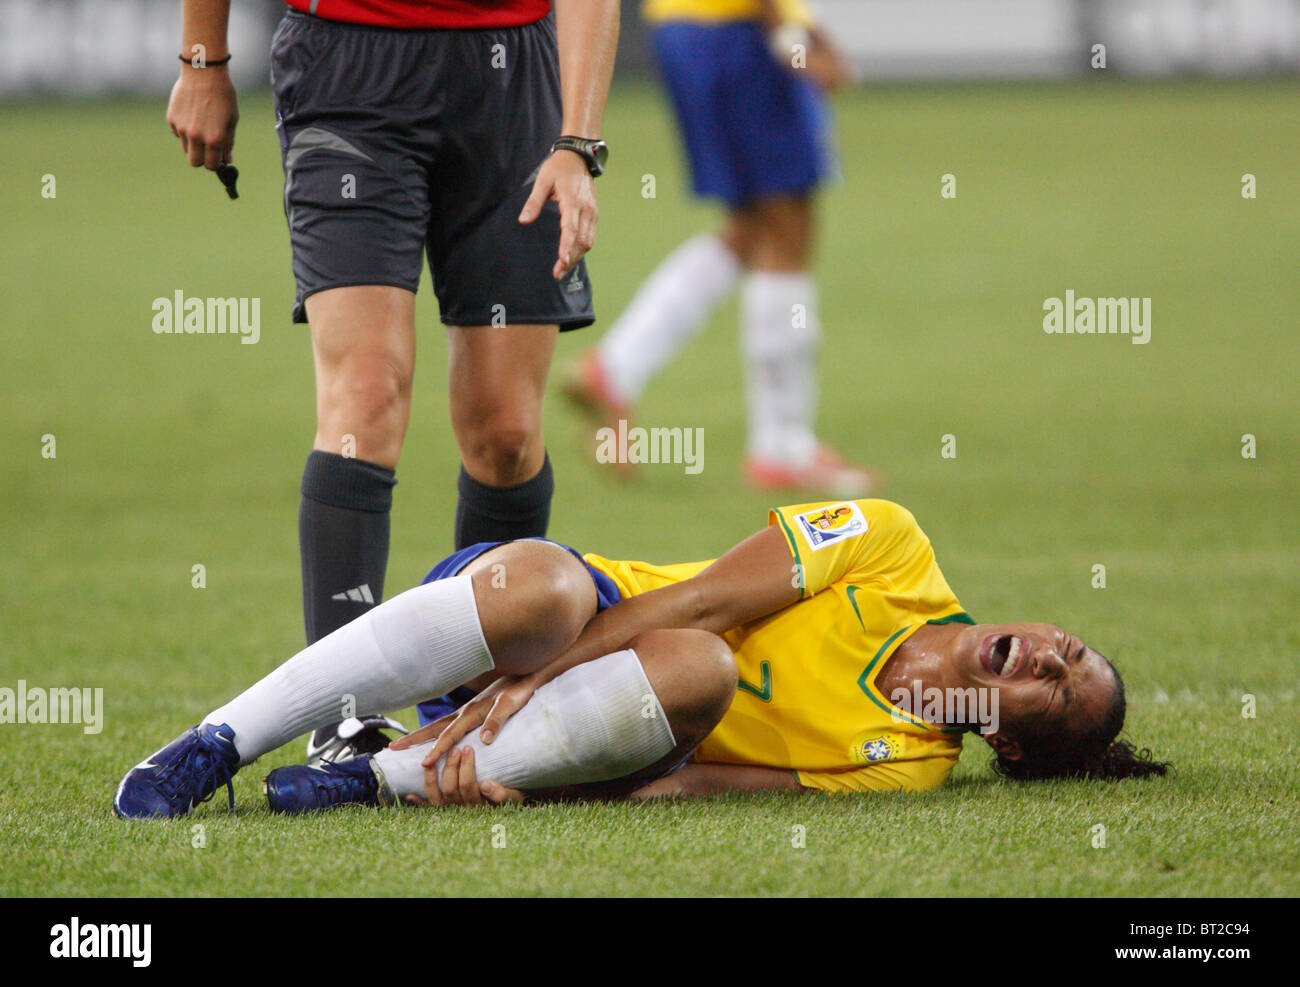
950,624,1115,757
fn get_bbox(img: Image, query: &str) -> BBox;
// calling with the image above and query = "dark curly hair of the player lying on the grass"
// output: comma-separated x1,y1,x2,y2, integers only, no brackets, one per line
993,659,1173,782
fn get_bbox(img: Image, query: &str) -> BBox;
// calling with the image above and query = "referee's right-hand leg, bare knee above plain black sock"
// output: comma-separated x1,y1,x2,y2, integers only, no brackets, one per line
447,325,559,549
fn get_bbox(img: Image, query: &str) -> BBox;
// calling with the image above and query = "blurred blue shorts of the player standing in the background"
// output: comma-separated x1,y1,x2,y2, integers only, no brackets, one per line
653,21,835,205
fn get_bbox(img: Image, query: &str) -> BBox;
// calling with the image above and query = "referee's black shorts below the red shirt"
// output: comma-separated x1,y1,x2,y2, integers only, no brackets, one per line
270,10,594,329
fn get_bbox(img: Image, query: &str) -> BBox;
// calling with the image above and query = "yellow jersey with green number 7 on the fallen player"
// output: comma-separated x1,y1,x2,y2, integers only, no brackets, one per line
584,499,974,791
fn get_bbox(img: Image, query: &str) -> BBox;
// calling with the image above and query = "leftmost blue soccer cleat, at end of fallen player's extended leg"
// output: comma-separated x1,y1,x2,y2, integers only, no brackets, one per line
113,723,239,819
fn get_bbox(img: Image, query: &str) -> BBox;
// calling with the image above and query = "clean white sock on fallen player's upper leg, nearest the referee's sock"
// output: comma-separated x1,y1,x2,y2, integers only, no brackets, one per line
203,576,494,765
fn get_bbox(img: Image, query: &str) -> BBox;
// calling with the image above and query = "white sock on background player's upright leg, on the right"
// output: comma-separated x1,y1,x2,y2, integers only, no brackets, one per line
740,270,822,467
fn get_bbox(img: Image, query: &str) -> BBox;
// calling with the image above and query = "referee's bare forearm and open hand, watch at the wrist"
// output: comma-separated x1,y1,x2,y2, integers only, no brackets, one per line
519,0,619,281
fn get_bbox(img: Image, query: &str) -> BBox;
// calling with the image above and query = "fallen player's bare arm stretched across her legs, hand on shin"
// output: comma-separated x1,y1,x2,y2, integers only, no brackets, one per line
394,527,801,766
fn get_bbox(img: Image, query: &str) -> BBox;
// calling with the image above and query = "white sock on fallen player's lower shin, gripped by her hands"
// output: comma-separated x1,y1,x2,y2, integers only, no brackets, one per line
374,649,677,802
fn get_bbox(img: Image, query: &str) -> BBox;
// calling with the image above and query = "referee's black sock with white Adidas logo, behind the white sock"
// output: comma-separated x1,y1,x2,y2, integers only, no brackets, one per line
298,450,397,644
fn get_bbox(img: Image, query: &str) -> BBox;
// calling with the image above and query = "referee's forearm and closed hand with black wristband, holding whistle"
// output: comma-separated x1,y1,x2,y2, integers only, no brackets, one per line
166,0,239,172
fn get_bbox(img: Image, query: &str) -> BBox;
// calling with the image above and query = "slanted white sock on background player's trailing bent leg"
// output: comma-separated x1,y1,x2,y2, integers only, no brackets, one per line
597,233,741,404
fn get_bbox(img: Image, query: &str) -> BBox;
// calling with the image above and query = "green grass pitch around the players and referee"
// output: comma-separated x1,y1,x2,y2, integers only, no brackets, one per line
0,77,1300,896
